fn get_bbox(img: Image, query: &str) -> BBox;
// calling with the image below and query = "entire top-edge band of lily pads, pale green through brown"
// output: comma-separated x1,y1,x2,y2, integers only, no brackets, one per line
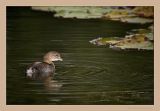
32,6,154,24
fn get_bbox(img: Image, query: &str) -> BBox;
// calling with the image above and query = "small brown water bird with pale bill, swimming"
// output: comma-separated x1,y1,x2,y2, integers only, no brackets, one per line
26,51,63,79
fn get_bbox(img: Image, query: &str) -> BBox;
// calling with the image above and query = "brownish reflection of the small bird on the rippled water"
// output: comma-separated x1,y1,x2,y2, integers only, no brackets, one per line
27,73,62,92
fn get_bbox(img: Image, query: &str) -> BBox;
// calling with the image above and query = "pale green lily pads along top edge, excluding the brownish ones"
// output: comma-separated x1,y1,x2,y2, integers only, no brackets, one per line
32,6,111,19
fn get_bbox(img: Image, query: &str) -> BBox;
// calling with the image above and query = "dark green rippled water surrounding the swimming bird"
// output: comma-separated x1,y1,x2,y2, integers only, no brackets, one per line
7,7,154,105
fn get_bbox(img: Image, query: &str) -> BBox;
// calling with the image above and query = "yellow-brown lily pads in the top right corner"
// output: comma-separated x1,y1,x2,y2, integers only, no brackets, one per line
103,6,154,24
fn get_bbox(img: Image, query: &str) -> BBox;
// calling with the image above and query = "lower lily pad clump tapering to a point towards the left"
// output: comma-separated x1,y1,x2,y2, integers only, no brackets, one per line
89,26,153,50
